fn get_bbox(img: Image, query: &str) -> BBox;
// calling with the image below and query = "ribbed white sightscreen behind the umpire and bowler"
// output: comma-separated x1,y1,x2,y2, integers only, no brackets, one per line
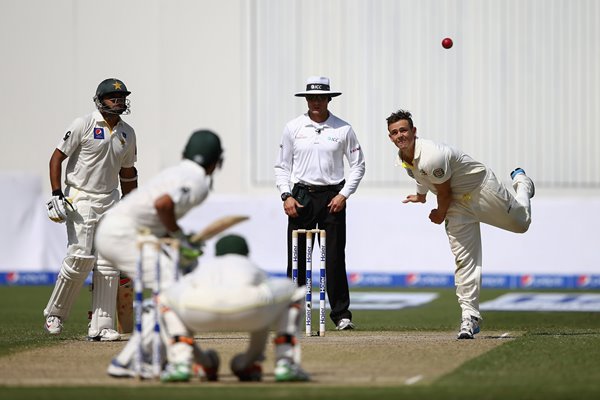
248,0,600,188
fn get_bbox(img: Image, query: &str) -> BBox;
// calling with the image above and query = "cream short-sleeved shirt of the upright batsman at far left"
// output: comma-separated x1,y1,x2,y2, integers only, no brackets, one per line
56,111,137,194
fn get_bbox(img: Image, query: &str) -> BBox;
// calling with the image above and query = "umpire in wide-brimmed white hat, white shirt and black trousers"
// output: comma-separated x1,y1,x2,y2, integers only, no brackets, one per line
275,76,365,330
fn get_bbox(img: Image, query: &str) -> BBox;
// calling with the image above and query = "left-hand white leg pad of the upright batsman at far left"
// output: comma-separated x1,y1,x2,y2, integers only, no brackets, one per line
44,255,96,321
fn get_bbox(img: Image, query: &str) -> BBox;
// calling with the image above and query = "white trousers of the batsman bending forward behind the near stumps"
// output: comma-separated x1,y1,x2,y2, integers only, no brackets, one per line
96,214,175,290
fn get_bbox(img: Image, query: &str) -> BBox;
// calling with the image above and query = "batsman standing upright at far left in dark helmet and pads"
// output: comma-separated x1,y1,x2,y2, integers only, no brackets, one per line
44,78,137,341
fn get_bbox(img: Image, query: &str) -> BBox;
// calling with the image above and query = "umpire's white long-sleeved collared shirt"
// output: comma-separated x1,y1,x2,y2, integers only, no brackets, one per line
275,113,365,198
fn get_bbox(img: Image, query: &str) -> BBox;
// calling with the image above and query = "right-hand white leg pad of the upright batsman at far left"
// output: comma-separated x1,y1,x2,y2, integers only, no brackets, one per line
88,258,119,337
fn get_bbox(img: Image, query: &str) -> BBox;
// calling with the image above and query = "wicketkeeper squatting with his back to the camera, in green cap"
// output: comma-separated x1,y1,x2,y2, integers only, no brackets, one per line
159,235,309,382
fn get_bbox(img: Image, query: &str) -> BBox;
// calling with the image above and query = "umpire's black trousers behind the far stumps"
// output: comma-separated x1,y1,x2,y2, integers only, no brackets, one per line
287,182,352,325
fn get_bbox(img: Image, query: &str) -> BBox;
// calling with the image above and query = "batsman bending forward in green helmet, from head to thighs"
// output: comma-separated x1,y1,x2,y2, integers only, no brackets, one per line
96,130,223,298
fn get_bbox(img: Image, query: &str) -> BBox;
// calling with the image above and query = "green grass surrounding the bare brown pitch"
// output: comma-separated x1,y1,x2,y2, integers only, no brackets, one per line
0,287,600,400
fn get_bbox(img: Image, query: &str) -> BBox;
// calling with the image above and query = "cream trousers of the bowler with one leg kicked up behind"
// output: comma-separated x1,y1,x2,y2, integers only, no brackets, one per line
446,170,533,319
